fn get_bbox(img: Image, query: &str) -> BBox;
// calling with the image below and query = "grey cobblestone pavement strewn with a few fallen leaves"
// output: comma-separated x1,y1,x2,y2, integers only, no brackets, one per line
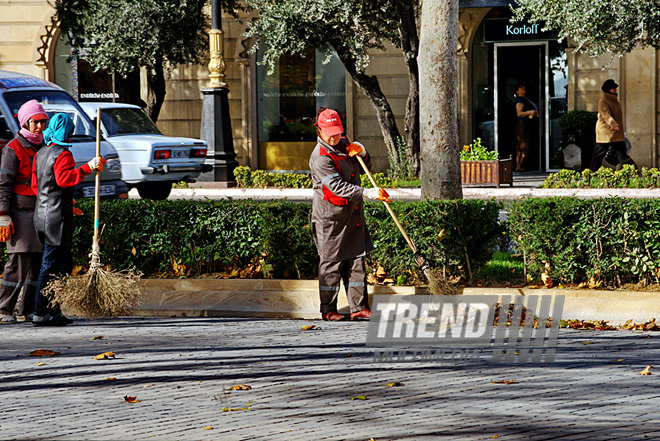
0,318,660,441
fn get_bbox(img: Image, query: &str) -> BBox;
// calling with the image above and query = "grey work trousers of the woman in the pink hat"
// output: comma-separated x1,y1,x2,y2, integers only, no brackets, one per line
0,253,41,315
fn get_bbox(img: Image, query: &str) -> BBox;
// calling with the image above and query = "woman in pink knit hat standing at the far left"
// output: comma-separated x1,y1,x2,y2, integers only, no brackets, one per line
0,100,48,323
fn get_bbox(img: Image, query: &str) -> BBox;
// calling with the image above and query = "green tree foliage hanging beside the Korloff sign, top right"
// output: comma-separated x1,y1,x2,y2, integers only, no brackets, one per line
514,0,660,56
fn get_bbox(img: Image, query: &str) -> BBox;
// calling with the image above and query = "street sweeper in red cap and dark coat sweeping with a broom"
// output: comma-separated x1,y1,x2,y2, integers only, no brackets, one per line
309,109,389,320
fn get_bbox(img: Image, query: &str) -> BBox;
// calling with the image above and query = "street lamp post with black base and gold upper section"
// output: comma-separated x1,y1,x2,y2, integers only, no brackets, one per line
201,0,238,187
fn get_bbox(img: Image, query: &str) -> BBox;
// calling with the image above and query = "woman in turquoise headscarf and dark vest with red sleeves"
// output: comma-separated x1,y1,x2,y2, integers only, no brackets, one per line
32,113,105,326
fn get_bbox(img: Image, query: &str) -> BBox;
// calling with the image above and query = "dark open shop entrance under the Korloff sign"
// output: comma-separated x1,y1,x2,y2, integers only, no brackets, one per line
493,42,550,171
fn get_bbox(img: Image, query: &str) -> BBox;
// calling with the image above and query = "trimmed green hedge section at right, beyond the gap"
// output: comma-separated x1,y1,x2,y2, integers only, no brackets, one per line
508,198,660,286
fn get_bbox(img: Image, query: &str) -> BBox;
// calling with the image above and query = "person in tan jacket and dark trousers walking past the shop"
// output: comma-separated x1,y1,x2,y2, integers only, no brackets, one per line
590,79,637,172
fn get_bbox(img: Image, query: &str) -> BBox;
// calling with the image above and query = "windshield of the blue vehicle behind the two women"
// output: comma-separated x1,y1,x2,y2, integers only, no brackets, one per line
5,90,96,139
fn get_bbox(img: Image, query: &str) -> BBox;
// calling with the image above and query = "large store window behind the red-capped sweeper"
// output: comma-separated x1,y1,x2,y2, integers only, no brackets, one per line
257,49,346,171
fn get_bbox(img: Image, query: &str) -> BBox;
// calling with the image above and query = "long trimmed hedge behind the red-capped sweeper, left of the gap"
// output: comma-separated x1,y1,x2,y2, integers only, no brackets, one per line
0,200,502,281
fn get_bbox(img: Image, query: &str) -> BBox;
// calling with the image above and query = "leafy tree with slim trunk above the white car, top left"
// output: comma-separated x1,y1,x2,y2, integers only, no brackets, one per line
53,0,242,121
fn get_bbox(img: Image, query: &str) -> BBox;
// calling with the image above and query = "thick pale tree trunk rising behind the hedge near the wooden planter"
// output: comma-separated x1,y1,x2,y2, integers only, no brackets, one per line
419,0,463,199
